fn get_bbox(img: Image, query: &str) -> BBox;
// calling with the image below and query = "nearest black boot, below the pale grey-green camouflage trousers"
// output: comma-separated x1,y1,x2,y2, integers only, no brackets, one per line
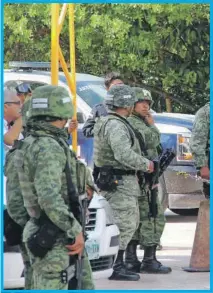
109,250,140,281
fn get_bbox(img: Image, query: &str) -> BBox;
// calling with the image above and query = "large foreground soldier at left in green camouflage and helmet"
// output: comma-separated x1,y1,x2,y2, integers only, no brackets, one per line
7,86,94,290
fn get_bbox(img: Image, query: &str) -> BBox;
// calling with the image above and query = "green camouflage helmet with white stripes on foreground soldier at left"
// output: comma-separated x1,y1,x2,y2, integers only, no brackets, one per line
28,85,73,119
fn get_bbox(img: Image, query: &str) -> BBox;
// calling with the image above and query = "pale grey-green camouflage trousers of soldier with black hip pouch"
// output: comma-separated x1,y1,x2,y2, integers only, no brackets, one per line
101,176,140,250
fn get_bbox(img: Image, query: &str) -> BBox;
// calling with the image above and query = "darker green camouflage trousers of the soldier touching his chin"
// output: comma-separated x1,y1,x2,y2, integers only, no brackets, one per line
132,191,165,246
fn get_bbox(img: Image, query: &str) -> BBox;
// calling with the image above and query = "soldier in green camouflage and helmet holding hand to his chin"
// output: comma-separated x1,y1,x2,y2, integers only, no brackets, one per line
125,87,171,274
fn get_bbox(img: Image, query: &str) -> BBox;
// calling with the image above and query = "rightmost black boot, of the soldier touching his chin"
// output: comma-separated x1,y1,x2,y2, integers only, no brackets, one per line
140,245,172,274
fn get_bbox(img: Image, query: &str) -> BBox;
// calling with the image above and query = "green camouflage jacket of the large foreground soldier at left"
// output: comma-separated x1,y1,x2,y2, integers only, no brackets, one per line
5,131,81,238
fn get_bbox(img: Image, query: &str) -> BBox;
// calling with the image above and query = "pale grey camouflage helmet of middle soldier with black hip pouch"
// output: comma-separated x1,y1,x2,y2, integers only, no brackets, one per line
105,84,136,108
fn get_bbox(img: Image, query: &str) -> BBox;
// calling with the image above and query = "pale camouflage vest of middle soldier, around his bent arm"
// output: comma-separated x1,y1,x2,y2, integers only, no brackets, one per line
94,114,141,170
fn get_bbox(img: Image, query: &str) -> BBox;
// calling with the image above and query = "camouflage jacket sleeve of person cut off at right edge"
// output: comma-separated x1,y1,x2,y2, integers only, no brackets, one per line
190,103,210,168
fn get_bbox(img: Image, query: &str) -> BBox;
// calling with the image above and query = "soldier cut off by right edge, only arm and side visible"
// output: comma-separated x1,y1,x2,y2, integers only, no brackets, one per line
190,102,210,198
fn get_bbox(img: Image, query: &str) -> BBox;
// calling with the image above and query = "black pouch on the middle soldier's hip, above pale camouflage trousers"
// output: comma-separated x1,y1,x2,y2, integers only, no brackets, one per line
96,166,118,191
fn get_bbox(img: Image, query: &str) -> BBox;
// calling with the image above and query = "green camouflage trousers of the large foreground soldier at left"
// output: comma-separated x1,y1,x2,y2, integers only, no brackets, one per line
26,242,95,290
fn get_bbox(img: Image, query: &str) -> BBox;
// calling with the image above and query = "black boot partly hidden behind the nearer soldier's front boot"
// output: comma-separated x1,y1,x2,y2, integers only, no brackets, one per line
125,240,141,273
